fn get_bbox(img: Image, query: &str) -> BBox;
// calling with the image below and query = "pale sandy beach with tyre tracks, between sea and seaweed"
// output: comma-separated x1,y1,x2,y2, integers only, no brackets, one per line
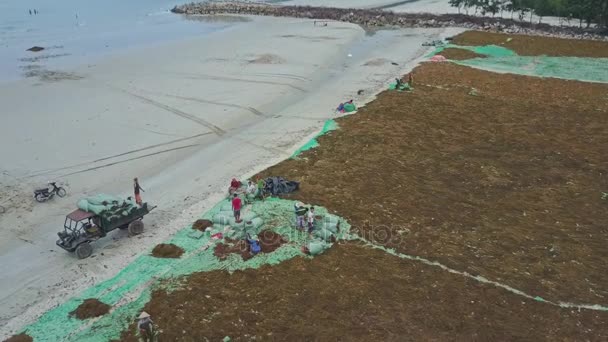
0,11,456,337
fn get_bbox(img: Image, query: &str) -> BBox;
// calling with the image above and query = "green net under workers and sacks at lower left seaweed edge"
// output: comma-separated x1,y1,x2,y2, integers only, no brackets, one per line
19,198,353,342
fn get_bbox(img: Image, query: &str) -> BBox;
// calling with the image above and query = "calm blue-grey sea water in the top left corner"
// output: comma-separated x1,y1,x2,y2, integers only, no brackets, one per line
0,0,242,81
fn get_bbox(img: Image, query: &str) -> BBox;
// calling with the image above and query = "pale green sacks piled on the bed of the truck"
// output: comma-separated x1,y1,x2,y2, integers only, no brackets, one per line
78,194,139,222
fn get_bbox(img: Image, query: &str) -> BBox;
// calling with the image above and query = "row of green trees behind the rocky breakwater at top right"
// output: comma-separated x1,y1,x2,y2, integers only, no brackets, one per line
450,0,608,28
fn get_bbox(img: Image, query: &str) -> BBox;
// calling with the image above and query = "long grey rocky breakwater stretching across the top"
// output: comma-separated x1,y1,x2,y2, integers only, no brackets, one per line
171,2,608,40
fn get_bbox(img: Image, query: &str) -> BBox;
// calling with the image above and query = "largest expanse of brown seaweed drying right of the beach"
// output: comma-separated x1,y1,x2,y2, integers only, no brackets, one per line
117,29,608,341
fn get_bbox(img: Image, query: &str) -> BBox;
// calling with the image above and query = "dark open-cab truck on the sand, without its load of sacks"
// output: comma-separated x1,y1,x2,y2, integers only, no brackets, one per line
57,203,156,259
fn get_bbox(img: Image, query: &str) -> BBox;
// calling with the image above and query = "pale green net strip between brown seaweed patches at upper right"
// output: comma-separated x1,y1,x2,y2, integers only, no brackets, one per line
431,44,608,83
